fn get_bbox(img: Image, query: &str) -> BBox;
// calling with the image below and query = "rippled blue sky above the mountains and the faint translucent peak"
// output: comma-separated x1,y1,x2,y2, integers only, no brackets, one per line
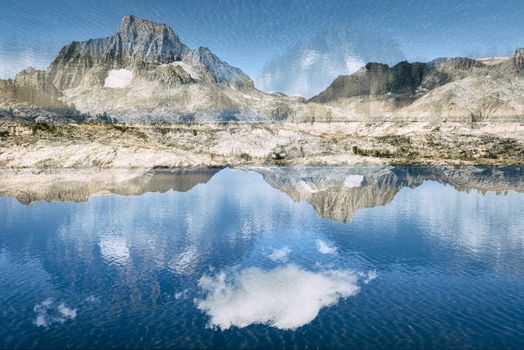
0,0,524,78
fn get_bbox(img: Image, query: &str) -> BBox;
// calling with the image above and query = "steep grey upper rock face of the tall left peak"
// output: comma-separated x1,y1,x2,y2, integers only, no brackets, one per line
48,16,252,90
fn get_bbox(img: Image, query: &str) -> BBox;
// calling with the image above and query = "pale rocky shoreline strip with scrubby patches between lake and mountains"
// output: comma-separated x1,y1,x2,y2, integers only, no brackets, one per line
0,121,524,169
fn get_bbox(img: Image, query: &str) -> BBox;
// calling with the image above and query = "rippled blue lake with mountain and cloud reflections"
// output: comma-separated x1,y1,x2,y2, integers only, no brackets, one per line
0,167,524,349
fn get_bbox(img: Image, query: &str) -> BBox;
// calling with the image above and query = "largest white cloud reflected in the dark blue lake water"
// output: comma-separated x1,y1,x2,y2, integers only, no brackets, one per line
195,264,360,329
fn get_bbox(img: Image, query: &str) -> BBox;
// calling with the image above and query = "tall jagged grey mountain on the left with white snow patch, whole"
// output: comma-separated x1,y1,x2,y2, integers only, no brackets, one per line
0,16,297,122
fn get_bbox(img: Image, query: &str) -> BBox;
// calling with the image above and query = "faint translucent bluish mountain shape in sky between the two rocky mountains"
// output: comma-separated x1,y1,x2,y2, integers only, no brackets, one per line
257,25,404,98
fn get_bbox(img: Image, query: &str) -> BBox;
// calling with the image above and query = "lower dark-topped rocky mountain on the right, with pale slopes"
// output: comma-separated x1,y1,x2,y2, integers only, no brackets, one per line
309,49,524,119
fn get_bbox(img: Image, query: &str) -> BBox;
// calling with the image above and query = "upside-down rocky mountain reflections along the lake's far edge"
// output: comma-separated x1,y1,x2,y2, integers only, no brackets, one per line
0,166,524,222
